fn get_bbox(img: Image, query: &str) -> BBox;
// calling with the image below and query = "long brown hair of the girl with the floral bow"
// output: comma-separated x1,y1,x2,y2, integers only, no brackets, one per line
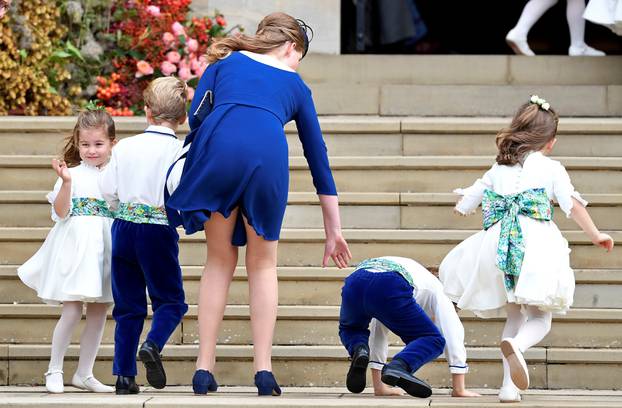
496,102,559,166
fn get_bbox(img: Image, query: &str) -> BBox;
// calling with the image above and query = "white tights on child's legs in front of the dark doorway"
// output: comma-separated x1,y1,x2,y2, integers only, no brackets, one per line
514,0,585,47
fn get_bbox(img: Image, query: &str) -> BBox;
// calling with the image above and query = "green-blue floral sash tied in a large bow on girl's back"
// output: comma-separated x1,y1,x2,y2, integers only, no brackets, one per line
482,188,553,290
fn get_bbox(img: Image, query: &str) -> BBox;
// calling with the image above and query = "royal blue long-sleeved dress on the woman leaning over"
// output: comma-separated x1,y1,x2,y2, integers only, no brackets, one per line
167,52,337,246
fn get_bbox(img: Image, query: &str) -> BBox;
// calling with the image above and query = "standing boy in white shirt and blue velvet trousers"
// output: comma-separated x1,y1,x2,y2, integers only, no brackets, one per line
99,77,188,394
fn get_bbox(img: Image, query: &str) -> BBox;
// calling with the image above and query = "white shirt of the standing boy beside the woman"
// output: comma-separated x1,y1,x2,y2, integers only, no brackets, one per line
99,125,183,210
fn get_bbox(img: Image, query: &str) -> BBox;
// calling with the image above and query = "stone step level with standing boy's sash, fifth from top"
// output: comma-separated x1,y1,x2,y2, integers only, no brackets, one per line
0,191,622,230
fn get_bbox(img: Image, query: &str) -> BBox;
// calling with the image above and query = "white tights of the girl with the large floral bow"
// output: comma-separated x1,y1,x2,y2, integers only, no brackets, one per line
502,303,553,387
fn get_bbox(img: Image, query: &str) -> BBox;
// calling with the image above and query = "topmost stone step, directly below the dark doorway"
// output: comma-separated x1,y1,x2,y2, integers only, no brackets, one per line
299,54,622,85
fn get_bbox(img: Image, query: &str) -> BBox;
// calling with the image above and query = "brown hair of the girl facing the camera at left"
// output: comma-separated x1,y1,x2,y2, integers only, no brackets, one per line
62,109,116,167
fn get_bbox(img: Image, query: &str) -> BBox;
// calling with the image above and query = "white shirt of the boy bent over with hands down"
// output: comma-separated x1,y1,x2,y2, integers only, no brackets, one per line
369,256,469,374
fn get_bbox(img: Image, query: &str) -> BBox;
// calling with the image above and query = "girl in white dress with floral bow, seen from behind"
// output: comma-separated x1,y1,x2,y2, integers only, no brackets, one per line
439,95,613,402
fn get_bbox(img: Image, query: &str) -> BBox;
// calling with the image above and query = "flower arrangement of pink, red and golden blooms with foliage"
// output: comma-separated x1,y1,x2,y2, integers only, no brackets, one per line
0,0,242,116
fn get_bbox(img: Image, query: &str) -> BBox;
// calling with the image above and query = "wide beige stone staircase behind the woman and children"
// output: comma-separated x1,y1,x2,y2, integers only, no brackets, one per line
0,56,622,406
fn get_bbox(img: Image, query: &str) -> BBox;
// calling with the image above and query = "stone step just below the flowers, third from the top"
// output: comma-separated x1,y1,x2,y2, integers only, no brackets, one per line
0,116,622,157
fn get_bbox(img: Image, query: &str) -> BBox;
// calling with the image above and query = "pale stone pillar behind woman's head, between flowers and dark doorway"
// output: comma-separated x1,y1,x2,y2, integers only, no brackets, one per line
191,0,341,54
